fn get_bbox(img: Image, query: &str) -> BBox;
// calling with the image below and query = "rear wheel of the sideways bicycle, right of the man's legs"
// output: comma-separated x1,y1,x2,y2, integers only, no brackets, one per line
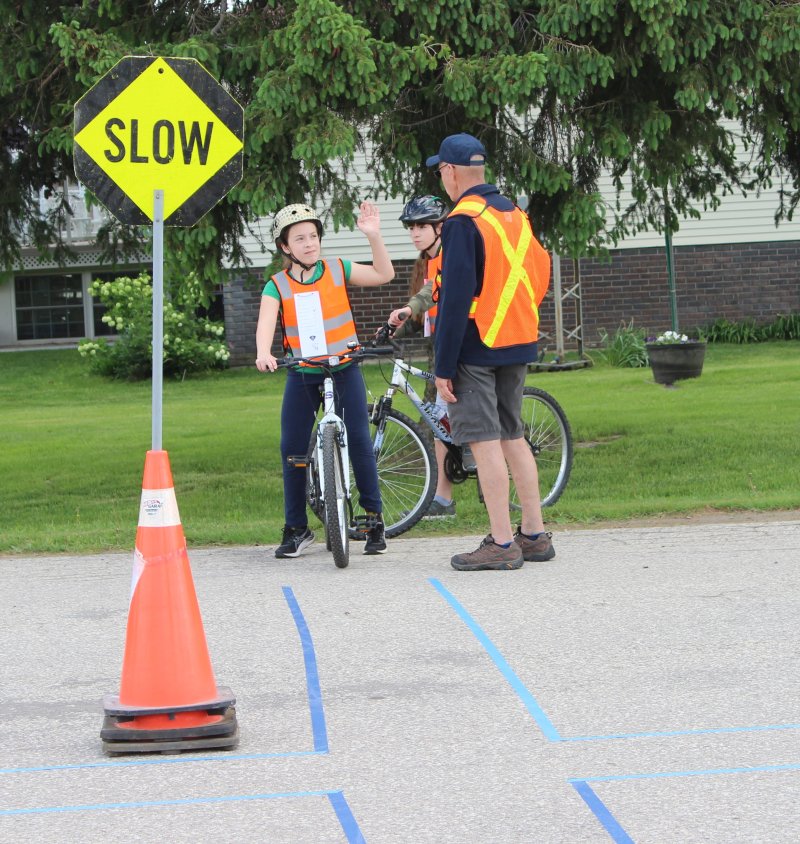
510,387,572,512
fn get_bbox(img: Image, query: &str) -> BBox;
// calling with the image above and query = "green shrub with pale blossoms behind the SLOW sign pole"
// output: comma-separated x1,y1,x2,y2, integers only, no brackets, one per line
78,273,230,379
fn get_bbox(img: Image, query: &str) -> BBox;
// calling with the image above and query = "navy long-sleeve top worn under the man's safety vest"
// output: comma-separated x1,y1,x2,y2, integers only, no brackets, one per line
434,185,536,379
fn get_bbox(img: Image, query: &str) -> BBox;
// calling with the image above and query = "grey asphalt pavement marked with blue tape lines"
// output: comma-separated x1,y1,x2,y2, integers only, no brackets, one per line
0,519,800,844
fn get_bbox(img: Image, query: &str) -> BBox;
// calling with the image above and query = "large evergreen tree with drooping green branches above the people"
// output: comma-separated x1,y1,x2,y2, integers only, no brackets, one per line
0,0,800,284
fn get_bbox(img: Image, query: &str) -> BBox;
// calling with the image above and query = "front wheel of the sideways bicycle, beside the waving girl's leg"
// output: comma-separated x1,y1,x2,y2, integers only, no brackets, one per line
369,406,437,537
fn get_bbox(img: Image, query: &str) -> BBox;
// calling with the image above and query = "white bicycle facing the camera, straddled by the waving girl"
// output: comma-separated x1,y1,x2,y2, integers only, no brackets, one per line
277,346,393,569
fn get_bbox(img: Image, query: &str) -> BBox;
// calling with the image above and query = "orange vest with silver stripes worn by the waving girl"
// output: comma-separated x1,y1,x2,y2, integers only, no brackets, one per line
272,258,358,357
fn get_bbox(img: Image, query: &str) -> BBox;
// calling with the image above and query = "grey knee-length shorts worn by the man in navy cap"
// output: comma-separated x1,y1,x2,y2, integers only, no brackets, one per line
448,363,528,443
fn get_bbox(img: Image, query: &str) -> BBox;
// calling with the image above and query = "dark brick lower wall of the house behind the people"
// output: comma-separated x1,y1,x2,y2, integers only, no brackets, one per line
225,241,800,366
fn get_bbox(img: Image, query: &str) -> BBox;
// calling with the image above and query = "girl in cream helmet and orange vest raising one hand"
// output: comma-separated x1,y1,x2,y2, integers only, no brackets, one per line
256,202,394,557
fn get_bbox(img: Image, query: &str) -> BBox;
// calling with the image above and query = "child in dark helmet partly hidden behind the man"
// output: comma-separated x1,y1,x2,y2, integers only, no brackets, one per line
387,196,456,519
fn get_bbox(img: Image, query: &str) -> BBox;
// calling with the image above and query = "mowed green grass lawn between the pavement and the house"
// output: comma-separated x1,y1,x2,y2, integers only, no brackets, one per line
0,342,800,553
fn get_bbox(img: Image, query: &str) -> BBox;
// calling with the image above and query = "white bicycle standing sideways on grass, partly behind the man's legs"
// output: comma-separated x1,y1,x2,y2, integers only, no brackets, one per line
369,323,573,537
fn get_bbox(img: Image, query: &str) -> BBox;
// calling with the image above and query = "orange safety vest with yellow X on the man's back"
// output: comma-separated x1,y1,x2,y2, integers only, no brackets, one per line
450,196,550,349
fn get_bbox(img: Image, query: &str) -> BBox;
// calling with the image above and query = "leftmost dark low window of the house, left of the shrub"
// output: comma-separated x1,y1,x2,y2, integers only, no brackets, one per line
14,273,86,340
